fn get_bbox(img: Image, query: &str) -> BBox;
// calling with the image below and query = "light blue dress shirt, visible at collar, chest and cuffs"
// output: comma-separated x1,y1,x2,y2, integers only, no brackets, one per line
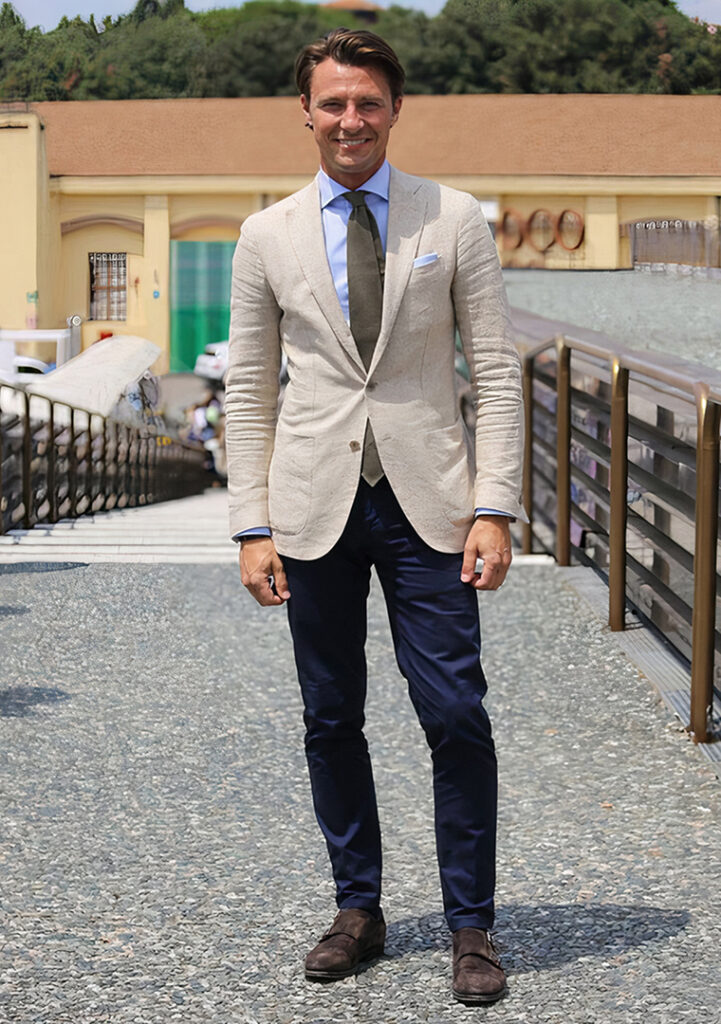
234,160,509,541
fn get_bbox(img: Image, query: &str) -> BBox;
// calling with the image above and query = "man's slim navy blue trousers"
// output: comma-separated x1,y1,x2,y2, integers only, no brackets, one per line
283,478,497,931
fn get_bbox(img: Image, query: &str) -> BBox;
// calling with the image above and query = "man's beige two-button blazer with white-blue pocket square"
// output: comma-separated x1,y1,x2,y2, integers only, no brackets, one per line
225,169,525,558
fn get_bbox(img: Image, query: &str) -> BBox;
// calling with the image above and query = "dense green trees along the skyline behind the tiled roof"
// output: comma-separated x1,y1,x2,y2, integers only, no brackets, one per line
0,0,721,100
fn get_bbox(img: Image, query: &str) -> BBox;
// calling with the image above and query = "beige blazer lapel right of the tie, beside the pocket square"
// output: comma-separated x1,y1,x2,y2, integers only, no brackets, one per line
369,167,426,375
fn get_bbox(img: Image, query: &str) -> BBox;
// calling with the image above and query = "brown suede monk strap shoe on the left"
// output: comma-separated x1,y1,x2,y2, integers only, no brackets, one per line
305,907,385,981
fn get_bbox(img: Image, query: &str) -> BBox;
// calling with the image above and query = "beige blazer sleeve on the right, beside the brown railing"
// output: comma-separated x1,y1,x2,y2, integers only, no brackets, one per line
453,197,527,521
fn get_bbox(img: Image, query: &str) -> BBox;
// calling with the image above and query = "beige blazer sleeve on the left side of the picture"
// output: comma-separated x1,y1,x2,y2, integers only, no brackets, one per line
225,218,281,537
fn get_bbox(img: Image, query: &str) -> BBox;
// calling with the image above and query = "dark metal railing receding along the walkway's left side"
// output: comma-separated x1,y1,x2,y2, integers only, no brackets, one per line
0,384,209,534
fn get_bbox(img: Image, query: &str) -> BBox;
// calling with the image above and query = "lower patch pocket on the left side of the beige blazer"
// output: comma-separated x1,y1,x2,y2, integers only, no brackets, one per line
268,434,315,534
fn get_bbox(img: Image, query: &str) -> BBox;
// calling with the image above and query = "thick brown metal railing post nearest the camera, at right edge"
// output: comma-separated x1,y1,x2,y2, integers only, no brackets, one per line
690,385,721,743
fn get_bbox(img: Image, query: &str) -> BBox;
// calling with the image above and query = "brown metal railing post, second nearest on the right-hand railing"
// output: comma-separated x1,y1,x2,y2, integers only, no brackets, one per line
608,359,629,631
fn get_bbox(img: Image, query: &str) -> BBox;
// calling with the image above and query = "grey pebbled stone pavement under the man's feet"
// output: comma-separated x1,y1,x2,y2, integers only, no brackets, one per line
0,562,721,1024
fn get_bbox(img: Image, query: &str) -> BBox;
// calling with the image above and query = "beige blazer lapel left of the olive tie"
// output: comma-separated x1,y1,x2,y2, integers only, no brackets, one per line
288,181,366,375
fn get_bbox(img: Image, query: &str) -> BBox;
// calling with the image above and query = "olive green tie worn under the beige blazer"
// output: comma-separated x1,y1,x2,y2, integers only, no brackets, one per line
343,191,385,486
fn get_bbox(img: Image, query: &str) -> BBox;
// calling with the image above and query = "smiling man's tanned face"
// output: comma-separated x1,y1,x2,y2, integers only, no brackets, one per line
300,57,401,188
